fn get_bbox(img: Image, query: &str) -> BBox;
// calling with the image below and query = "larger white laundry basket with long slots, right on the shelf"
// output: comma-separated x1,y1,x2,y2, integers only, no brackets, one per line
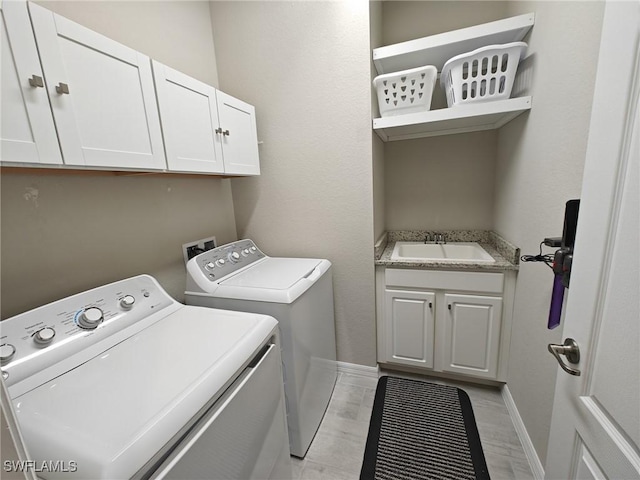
440,42,527,107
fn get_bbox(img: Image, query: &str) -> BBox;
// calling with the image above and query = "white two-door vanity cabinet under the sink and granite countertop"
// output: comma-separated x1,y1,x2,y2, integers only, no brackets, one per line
376,266,515,381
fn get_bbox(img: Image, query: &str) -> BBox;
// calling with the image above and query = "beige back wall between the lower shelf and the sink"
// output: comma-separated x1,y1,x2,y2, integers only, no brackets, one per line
384,131,497,230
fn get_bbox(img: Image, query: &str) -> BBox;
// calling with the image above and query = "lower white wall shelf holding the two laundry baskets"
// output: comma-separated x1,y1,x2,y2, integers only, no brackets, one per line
373,97,531,142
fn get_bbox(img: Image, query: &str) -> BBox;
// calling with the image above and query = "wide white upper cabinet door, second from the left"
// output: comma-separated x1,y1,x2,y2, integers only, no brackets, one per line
29,3,166,170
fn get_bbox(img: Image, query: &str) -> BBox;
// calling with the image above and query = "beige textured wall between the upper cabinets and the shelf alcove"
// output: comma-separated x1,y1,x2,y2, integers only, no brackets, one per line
211,1,376,365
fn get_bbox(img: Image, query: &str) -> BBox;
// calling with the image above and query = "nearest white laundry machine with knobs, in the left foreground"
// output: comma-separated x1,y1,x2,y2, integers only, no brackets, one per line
0,275,292,479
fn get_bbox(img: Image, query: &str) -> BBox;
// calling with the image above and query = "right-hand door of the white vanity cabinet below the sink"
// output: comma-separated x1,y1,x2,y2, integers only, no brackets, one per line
442,294,502,379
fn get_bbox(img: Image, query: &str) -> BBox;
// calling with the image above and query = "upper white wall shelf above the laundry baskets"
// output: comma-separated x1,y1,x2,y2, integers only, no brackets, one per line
373,13,535,74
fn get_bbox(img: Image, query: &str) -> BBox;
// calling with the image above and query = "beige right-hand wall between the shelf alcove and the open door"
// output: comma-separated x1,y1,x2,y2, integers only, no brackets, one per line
494,1,603,465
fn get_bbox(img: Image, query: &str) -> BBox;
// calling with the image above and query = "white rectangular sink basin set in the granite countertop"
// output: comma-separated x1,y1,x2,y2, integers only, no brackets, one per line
391,242,495,263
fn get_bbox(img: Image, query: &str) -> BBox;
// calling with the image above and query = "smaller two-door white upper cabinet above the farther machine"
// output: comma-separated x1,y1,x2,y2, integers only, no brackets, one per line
152,60,260,175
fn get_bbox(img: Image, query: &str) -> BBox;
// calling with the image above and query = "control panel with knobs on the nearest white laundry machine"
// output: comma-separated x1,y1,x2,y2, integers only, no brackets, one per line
0,275,177,386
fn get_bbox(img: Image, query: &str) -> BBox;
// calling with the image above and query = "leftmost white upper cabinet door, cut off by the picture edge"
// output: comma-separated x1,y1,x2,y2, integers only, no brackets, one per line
0,1,62,164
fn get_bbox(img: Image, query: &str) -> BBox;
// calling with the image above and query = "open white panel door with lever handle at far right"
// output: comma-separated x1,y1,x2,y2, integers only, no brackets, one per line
546,0,640,479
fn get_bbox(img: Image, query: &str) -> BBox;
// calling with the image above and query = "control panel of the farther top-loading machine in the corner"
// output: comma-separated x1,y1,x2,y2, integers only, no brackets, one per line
194,239,265,282
